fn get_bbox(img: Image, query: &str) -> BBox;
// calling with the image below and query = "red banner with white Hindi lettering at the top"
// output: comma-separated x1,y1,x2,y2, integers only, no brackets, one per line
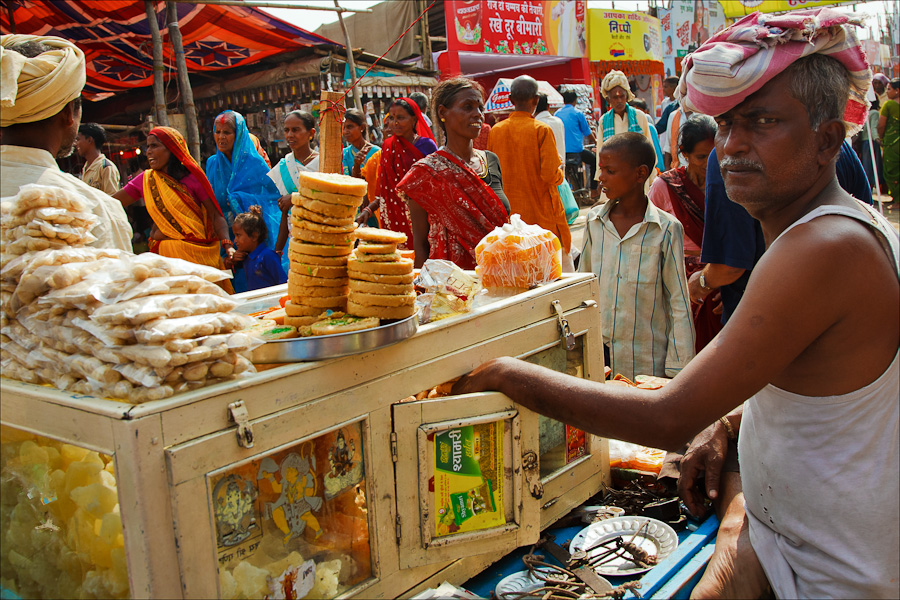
444,0,586,57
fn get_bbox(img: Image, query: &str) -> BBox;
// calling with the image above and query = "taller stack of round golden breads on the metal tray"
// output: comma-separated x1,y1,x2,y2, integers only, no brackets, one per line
284,172,366,327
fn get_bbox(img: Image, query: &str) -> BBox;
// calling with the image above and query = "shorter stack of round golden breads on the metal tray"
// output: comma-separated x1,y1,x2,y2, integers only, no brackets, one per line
347,227,416,319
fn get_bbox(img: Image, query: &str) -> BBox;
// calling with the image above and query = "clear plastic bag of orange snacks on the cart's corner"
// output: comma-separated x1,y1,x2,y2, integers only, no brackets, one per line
475,215,562,289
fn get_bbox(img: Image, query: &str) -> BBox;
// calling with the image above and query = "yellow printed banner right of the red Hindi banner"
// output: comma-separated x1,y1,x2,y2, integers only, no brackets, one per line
588,10,662,62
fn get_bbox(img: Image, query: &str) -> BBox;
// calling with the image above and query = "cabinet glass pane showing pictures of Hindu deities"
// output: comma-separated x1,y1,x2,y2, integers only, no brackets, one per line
207,422,372,598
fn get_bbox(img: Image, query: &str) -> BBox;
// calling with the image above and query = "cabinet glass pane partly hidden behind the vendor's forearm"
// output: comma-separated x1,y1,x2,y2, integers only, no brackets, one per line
524,337,588,478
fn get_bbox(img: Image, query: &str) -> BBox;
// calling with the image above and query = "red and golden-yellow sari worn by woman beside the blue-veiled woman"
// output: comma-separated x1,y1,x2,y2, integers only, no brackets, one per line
143,127,233,293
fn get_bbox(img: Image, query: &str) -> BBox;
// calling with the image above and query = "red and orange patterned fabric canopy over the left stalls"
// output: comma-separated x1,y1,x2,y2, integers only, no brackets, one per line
0,0,342,100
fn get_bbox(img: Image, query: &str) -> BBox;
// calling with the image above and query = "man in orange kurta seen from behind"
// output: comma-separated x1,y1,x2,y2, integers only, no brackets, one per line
487,75,572,255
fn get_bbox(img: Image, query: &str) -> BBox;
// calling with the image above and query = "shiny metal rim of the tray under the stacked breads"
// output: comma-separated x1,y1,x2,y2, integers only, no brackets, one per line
253,314,419,364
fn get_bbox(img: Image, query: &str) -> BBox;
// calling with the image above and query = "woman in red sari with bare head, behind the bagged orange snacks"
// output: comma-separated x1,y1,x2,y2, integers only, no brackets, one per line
398,77,509,269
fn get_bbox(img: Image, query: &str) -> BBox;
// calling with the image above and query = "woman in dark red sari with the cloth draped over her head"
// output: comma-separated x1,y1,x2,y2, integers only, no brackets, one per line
367,98,437,248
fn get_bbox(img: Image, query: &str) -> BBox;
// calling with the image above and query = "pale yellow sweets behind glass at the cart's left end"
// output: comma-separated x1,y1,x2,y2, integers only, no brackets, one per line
0,426,130,598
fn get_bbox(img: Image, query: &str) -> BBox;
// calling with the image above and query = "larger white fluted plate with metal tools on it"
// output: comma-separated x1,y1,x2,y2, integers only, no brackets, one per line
569,517,678,576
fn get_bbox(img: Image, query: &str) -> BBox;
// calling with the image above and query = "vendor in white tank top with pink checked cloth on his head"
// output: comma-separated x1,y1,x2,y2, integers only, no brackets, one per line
453,9,900,598
